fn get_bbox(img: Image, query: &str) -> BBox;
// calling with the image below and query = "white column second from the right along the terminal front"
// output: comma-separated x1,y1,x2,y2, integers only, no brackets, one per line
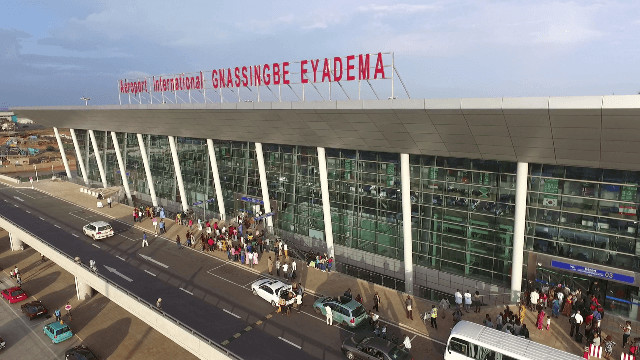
400,154,413,294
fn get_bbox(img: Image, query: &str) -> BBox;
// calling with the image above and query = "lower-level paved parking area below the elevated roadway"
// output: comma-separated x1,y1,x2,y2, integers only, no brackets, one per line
0,230,196,360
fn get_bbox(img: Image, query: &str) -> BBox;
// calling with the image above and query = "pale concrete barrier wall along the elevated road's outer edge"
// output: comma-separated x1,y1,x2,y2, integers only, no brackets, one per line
0,217,238,359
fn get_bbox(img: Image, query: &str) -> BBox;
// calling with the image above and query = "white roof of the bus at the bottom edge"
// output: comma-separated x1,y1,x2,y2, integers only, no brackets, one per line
450,321,584,360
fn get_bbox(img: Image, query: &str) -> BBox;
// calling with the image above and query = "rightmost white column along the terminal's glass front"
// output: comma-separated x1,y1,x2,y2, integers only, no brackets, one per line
511,162,529,302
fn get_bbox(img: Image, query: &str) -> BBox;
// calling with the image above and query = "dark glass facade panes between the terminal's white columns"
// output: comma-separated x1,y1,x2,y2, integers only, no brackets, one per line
77,131,640,310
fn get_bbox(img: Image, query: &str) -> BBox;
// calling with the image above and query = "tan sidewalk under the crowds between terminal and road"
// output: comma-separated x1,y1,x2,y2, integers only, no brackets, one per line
12,180,640,359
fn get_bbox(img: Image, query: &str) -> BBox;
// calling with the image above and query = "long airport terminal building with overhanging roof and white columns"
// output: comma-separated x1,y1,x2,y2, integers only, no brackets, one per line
12,59,640,319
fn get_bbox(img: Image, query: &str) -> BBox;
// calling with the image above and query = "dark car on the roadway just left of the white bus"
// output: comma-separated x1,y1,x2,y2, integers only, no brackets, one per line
342,336,411,360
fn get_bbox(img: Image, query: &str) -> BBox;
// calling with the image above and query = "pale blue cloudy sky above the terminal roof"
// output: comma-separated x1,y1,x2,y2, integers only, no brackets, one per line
0,0,640,107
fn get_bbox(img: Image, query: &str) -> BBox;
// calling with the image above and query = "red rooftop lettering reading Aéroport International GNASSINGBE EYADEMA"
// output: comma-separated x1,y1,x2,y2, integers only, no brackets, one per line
120,52,385,95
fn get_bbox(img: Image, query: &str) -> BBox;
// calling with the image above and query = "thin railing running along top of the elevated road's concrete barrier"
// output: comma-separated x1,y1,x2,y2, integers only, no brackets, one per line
3,217,242,359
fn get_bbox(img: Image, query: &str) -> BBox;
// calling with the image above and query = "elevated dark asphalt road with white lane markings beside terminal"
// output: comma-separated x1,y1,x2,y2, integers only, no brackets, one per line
0,186,443,359
